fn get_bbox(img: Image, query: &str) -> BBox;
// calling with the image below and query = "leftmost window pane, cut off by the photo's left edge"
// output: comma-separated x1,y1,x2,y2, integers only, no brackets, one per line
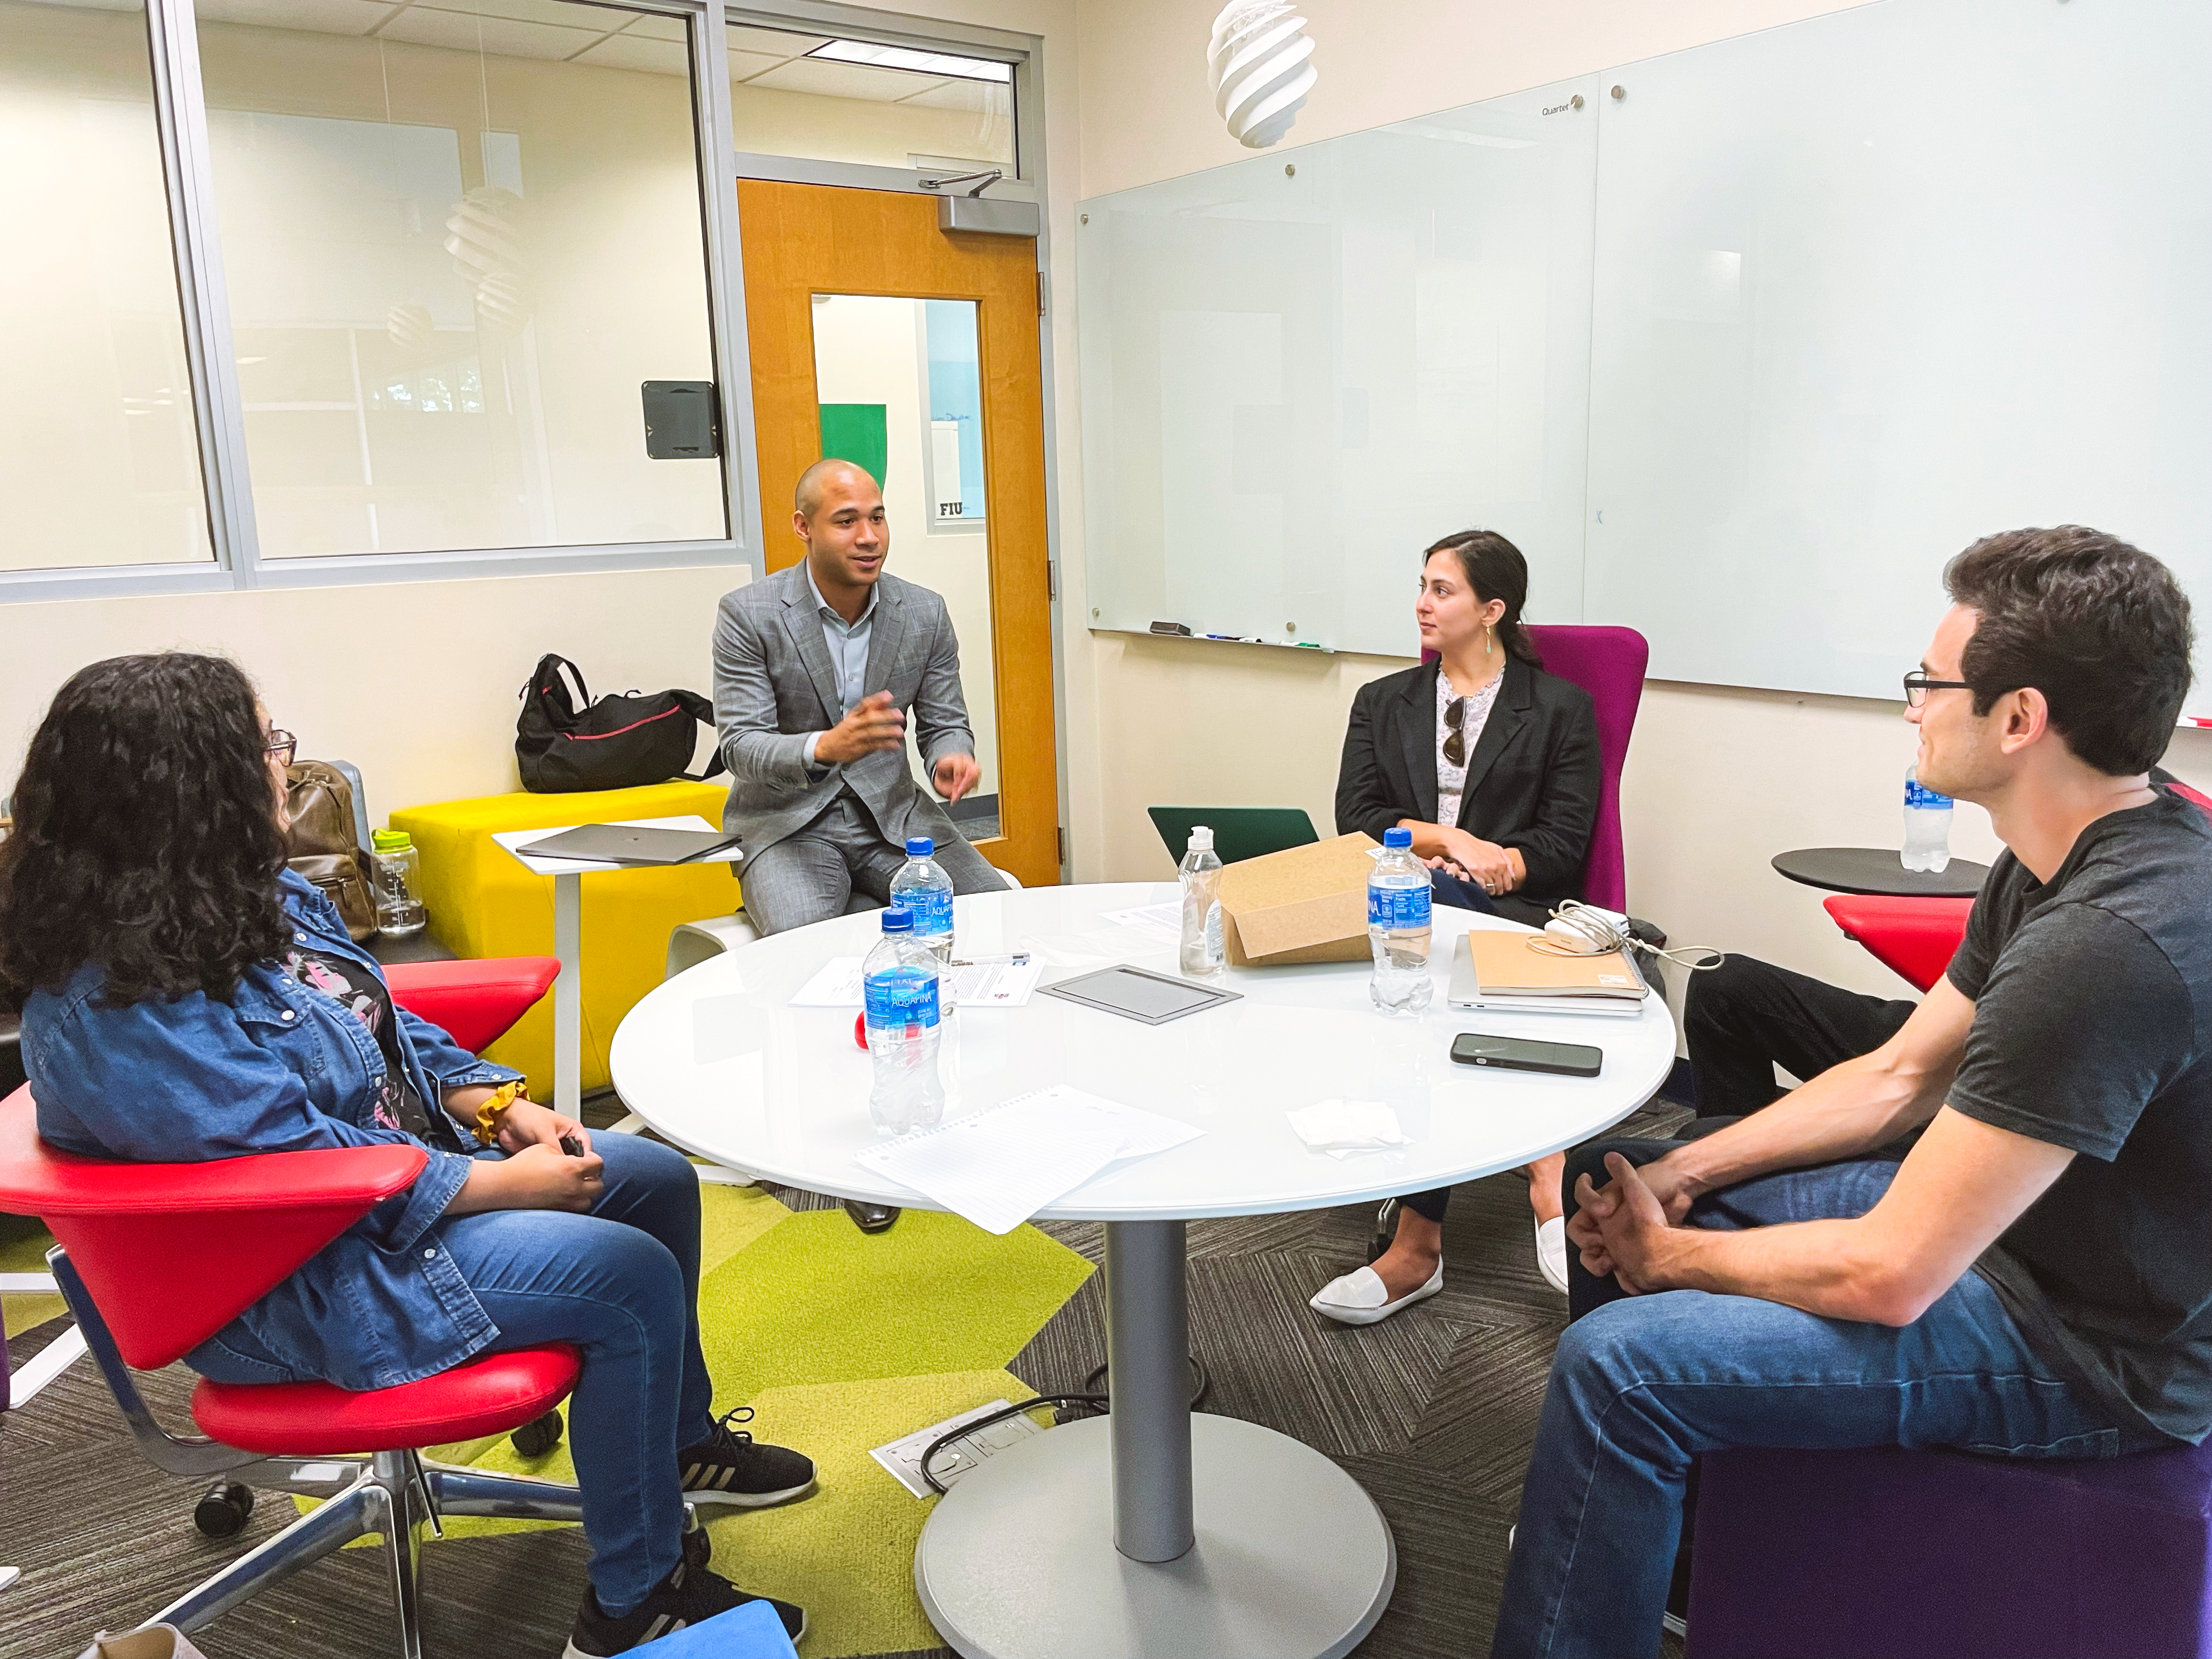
0,0,215,571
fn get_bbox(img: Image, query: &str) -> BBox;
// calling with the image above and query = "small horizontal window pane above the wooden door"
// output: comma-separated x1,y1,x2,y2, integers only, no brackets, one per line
730,24,1015,175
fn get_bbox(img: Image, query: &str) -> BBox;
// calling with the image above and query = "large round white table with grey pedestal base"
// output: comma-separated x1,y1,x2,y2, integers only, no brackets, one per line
613,883,1674,1659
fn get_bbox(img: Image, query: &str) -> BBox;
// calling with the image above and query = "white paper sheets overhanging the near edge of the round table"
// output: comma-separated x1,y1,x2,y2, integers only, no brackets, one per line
854,1084,1205,1232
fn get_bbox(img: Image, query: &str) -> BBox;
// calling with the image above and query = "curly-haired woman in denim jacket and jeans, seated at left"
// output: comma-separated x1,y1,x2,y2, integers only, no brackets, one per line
0,652,814,1659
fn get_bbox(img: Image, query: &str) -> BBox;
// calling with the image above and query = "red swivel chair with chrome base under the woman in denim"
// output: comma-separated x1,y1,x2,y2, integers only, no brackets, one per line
0,958,584,1659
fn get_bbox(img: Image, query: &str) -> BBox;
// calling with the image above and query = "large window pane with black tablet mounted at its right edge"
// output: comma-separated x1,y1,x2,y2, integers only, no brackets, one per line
199,0,728,560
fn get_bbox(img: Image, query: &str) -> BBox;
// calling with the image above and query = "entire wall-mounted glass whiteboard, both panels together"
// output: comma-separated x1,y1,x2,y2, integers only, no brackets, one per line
1077,0,2212,723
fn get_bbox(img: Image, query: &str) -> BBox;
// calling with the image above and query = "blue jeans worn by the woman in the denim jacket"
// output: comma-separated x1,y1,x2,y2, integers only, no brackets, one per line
201,1130,714,1617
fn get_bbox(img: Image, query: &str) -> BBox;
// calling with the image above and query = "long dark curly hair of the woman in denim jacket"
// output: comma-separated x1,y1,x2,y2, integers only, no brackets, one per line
0,650,292,1009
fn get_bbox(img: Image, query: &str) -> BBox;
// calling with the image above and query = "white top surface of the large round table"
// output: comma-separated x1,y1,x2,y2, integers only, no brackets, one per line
611,883,1674,1221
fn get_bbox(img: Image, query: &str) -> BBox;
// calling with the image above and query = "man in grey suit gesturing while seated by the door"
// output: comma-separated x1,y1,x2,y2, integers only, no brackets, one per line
714,460,1007,934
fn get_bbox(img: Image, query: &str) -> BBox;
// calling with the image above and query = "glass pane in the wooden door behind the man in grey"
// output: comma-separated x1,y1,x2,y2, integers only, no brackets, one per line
814,294,1000,840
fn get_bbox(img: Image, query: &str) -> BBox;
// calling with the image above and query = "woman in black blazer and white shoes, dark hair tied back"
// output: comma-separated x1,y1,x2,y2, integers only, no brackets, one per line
1312,531,1601,1325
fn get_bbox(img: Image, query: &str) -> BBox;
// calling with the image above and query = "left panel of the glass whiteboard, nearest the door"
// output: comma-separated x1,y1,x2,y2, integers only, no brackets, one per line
1077,82,1599,654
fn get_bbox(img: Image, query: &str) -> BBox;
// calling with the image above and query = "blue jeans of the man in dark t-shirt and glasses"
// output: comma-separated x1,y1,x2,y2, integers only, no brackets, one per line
1491,1142,2137,1659
